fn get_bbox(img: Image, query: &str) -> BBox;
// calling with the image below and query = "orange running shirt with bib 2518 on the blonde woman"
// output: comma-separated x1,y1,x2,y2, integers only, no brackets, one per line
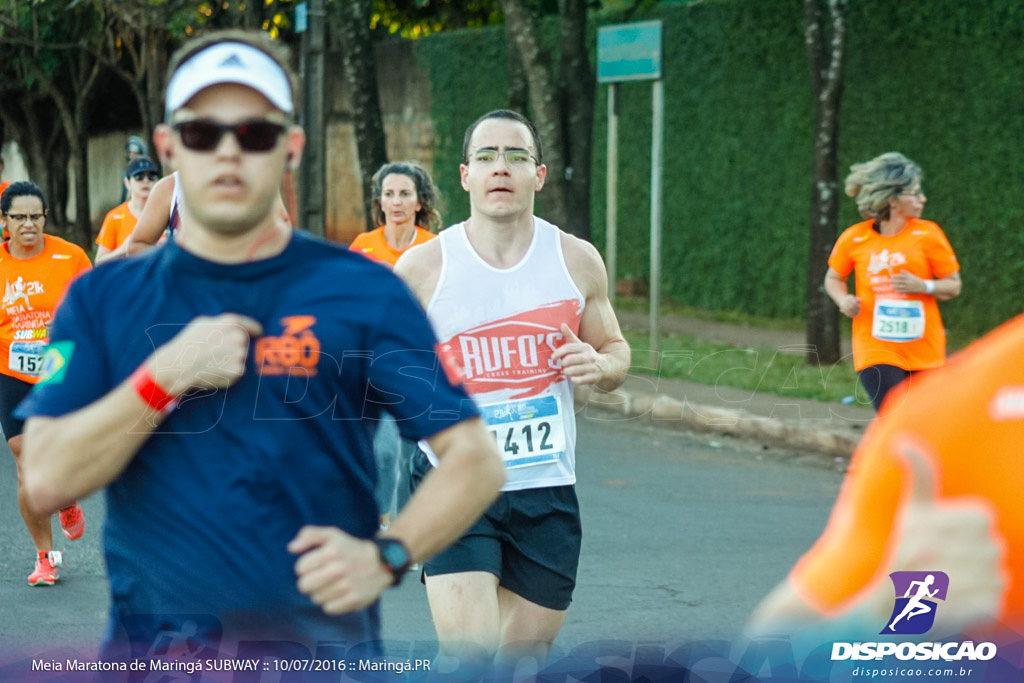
828,218,959,370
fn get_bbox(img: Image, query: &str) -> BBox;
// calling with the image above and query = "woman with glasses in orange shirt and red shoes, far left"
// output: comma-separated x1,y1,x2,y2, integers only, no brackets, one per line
0,182,92,586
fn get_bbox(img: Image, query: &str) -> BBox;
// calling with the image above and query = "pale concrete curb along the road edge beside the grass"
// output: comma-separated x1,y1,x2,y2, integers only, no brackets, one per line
575,387,864,459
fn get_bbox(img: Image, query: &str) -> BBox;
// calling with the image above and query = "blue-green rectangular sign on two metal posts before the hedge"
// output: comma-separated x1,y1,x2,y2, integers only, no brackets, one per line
597,20,665,357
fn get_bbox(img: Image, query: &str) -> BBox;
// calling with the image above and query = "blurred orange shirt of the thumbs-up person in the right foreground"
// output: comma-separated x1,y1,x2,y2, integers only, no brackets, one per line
790,315,1024,625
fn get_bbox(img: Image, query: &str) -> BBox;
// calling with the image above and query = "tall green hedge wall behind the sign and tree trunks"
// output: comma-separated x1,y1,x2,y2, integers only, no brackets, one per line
417,0,1024,336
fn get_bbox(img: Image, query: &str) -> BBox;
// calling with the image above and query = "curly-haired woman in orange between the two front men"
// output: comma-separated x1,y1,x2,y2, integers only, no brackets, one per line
348,162,441,527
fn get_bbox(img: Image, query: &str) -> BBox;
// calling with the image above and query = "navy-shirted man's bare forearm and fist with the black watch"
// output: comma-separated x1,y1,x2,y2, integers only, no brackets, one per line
289,418,505,614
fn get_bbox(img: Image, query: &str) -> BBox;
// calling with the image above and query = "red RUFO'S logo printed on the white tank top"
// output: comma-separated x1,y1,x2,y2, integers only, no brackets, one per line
440,299,583,398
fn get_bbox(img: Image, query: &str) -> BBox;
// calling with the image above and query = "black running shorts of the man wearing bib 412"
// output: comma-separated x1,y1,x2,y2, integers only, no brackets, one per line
417,454,583,609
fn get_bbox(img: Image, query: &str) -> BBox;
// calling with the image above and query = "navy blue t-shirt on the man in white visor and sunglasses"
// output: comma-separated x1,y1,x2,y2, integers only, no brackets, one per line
18,231,476,655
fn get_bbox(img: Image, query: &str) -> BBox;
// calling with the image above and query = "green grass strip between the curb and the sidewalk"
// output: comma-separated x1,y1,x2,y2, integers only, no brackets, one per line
624,330,867,402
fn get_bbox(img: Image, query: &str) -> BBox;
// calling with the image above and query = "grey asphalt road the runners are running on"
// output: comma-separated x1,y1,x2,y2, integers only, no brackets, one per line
0,417,842,680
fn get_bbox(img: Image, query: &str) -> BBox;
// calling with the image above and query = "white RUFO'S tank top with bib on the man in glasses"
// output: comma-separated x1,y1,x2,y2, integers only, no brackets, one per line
427,216,585,490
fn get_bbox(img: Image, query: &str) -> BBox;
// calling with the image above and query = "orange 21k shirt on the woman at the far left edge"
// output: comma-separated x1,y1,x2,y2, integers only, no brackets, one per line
0,234,92,384
